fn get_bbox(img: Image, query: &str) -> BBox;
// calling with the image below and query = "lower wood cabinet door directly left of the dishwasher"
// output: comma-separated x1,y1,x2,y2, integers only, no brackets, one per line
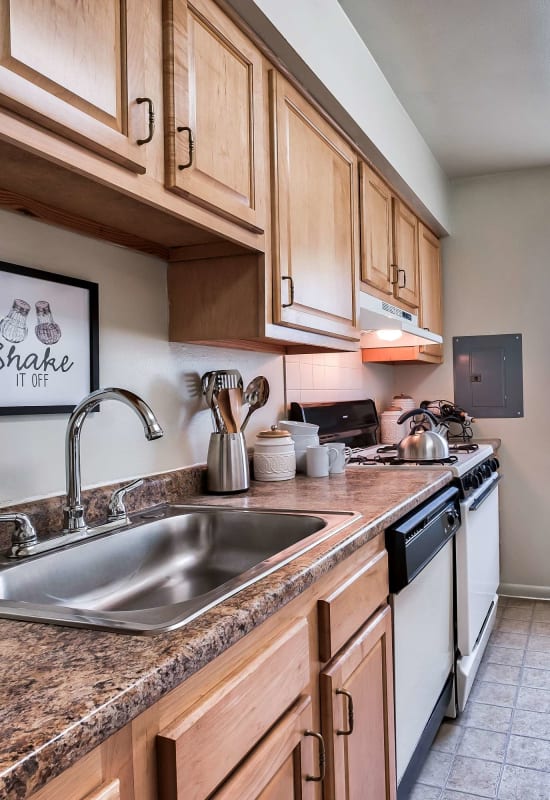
320,606,396,800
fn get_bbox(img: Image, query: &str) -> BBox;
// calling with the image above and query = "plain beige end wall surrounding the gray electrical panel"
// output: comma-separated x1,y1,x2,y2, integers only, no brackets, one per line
395,169,550,596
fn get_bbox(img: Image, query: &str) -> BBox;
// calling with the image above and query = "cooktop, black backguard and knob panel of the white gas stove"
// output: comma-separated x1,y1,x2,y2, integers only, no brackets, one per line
289,399,499,498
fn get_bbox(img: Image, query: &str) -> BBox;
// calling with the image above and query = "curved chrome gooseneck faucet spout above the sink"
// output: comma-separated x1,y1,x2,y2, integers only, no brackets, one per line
63,388,163,533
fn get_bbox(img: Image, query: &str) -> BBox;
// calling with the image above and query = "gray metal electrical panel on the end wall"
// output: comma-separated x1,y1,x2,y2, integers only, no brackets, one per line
453,333,523,417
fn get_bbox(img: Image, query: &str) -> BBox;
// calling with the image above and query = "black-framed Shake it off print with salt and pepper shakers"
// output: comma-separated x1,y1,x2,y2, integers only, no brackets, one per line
0,261,99,415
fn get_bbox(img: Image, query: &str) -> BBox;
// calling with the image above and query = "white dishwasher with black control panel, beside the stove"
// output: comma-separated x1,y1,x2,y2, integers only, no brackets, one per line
386,486,460,800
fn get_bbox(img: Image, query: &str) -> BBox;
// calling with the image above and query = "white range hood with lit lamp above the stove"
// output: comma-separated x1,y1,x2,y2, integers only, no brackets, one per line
359,292,443,348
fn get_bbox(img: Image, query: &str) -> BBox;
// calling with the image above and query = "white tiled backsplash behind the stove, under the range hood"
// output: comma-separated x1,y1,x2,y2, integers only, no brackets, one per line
286,352,394,410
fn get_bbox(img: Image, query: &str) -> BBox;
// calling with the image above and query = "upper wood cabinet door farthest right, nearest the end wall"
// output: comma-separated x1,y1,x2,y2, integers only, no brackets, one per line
418,223,443,357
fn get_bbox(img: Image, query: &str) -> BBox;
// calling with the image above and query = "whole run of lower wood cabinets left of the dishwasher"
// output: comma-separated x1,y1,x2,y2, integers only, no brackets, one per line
28,537,396,800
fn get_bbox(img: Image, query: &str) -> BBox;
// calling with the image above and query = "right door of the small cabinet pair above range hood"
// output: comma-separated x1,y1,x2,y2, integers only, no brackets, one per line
393,197,420,308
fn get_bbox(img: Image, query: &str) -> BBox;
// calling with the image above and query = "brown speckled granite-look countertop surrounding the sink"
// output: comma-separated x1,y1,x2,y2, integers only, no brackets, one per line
0,468,452,800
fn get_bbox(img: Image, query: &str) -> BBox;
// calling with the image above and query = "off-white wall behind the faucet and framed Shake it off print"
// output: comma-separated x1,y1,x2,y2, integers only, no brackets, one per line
0,212,284,504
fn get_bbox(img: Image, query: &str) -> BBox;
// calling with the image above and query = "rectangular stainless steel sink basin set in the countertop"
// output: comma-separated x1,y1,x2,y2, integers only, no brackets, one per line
0,505,356,634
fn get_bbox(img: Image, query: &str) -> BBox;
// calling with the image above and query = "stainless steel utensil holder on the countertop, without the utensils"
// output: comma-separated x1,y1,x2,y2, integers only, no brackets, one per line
206,431,250,494
